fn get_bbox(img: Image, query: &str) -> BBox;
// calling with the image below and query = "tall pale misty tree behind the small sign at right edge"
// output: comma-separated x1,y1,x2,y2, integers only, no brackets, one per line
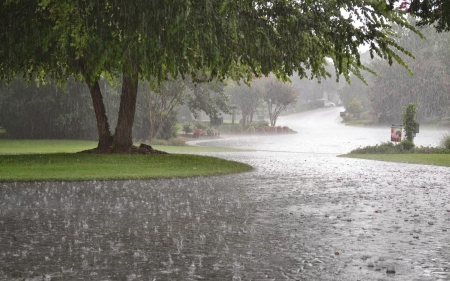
362,17,450,124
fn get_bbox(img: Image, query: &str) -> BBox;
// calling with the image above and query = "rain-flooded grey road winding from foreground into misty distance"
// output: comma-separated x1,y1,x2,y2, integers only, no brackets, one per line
0,108,450,280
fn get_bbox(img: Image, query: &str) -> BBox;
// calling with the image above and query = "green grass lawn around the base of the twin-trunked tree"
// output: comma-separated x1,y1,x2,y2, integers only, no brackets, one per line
0,139,252,181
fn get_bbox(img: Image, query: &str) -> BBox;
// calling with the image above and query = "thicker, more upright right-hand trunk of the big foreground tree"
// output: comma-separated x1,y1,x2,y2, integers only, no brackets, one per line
113,72,138,152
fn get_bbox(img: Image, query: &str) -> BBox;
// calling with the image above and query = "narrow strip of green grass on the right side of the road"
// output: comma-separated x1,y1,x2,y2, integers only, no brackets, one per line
339,153,450,167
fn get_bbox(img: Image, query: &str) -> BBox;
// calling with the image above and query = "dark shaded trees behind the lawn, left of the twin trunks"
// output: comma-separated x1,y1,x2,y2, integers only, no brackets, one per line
0,77,96,139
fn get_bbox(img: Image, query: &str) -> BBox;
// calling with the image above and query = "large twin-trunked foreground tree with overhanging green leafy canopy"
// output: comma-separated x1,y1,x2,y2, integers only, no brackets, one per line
0,0,414,152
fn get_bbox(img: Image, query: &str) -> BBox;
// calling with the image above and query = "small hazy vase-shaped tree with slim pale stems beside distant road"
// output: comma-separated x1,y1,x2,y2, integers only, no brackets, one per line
262,78,297,126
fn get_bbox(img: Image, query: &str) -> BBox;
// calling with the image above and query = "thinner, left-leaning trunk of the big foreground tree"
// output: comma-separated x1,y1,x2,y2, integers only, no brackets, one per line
86,79,112,151
